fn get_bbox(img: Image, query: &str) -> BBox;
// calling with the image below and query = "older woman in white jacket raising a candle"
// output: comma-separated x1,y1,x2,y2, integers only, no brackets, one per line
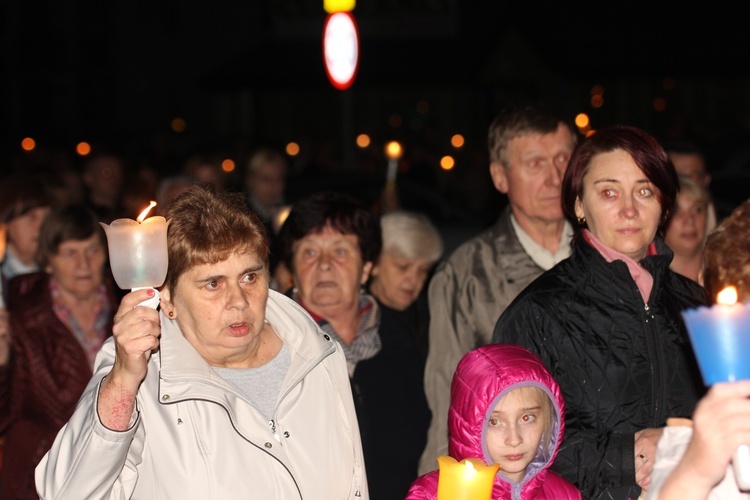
36,187,368,500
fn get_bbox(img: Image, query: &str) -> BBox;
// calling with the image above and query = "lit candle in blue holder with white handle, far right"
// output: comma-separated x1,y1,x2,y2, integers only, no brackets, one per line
682,286,750,491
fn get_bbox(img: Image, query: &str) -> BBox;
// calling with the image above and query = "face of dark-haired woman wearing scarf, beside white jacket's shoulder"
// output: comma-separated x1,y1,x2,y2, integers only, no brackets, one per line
294,225,372,318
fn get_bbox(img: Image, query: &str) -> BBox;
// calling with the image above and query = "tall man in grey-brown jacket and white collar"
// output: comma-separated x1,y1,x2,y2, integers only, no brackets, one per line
419,106,576,475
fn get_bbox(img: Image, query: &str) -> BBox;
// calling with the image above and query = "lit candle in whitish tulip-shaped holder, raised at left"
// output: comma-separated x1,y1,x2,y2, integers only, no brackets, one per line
101,201,169,308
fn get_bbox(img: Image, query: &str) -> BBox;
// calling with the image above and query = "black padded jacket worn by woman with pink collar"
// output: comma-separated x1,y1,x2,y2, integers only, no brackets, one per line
493,237,706,500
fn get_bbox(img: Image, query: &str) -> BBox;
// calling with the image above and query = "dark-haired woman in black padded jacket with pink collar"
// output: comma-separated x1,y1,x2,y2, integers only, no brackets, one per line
493,126,706,500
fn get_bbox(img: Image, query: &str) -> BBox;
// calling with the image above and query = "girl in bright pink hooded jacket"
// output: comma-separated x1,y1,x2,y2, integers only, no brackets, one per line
406,344,581,500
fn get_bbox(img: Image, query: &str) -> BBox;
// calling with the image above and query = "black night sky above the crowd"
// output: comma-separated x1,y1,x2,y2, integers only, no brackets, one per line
2,0,750,221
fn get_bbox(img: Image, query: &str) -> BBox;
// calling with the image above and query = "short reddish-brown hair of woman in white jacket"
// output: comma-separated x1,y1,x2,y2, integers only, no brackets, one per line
164,185,270,295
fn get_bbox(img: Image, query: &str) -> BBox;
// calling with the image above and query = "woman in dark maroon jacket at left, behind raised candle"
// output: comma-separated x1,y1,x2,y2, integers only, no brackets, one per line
0,205,115,499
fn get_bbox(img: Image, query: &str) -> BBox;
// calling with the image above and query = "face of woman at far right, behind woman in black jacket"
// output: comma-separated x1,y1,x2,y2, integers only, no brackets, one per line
665,192,708,255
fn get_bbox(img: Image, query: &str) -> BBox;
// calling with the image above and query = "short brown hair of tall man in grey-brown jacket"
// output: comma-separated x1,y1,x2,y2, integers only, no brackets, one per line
487,104,576,167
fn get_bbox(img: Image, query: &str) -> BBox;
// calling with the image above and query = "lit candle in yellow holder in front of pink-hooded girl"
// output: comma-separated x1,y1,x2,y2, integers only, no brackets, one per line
438,456,500,500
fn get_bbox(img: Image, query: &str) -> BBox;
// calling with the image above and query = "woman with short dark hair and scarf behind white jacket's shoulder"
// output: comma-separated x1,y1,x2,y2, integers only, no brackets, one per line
280,192,430,499
